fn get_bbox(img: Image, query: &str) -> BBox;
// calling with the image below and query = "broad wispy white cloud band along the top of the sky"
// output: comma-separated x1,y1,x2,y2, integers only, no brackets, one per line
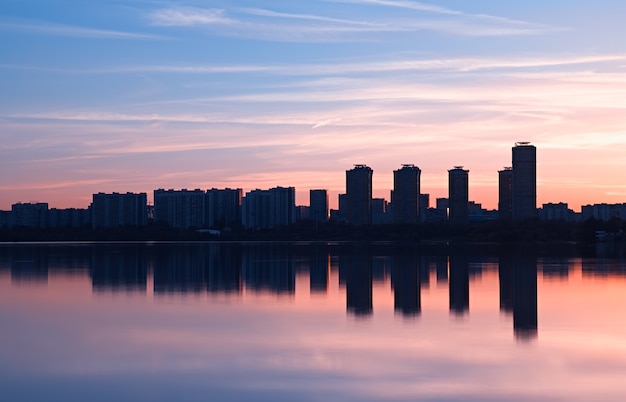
148,0,561,42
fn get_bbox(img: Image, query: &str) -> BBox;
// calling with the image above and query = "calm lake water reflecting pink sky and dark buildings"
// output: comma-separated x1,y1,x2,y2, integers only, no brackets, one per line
0,243,626,401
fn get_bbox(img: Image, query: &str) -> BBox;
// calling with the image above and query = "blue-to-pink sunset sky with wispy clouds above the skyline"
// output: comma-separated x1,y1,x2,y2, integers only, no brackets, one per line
0,0,626,211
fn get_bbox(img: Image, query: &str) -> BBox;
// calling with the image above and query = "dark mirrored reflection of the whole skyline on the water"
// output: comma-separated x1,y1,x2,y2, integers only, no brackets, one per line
7,243,626,339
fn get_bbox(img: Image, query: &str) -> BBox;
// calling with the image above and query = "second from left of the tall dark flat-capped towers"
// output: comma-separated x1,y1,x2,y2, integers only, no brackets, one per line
391,165,422,223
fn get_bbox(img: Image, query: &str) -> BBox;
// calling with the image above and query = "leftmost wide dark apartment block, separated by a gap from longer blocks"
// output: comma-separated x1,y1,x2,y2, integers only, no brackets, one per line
91,193,148,229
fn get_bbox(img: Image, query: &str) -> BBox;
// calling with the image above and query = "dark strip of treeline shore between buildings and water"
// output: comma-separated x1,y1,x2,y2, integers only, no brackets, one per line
0,218,626,243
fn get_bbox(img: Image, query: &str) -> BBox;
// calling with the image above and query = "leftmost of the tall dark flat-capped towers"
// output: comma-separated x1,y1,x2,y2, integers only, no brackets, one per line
346,165,373,225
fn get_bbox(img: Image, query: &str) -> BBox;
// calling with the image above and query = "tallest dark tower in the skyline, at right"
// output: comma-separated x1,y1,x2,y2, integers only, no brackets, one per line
512,142,537,220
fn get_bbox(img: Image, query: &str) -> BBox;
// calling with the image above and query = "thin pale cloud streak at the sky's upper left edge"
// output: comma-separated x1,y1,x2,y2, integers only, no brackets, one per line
0,21,167,40
